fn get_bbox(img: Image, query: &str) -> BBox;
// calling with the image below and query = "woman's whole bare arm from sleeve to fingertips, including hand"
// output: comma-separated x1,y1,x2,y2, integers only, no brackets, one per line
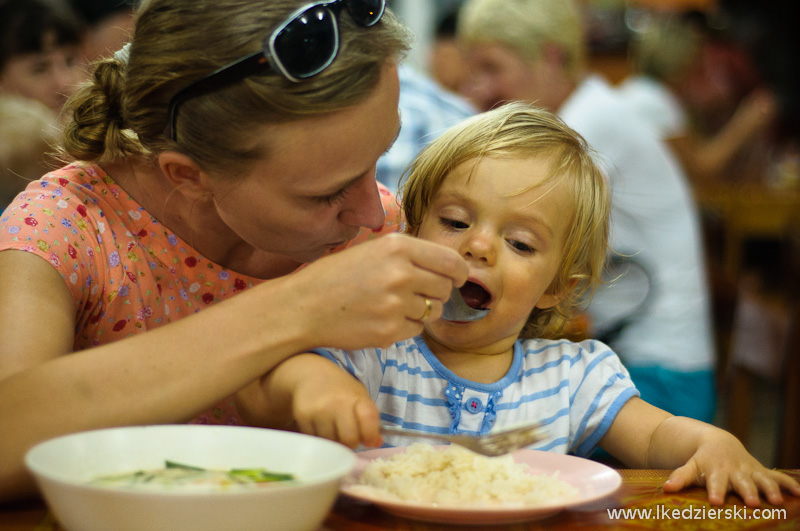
0,235,467,501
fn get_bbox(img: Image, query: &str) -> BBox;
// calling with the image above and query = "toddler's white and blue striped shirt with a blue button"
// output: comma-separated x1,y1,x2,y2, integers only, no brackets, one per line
316,336,639,456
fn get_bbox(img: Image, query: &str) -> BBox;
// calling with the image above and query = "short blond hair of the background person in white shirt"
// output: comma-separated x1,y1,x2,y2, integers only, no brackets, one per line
457,0,586,79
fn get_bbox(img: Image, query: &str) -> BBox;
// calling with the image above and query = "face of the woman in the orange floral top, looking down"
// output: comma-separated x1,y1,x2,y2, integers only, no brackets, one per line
205,65,400,262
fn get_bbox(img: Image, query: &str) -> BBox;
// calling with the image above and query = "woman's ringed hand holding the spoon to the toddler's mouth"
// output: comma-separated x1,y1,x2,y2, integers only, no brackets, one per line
290,234,468,350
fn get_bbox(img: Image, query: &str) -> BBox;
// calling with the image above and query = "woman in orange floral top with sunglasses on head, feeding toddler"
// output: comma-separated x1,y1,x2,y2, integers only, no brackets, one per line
0,0,466,499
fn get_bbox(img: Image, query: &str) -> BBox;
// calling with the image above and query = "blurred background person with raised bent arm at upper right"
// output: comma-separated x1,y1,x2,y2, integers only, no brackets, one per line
619,10,778,184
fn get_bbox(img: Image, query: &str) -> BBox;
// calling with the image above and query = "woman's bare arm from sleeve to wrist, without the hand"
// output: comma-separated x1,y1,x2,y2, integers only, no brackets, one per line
0,251,318,500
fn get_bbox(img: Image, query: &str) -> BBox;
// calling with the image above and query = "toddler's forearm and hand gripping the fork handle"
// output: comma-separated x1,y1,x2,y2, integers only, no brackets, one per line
237,353,381,448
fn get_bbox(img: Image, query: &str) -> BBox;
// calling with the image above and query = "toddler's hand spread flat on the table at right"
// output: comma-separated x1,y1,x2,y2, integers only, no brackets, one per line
664,429,800,507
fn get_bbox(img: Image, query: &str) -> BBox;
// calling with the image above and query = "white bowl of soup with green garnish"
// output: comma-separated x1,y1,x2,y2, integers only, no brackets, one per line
25,425,356,531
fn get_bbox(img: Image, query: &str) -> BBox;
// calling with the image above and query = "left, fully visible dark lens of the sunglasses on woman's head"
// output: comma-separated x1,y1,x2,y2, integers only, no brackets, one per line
273,7,338,79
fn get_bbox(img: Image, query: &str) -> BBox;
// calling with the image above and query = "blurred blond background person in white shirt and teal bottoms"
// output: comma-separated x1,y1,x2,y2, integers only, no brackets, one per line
458,0,715,421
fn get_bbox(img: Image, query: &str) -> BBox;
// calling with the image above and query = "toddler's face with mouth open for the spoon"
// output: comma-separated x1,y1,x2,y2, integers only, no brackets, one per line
418,157,574,346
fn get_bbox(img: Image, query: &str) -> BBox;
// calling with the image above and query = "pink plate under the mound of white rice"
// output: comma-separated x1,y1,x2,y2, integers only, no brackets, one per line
341,448,622,525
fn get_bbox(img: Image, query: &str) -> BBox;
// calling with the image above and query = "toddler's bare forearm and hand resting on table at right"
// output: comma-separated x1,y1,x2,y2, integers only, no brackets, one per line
600,398,800,507
